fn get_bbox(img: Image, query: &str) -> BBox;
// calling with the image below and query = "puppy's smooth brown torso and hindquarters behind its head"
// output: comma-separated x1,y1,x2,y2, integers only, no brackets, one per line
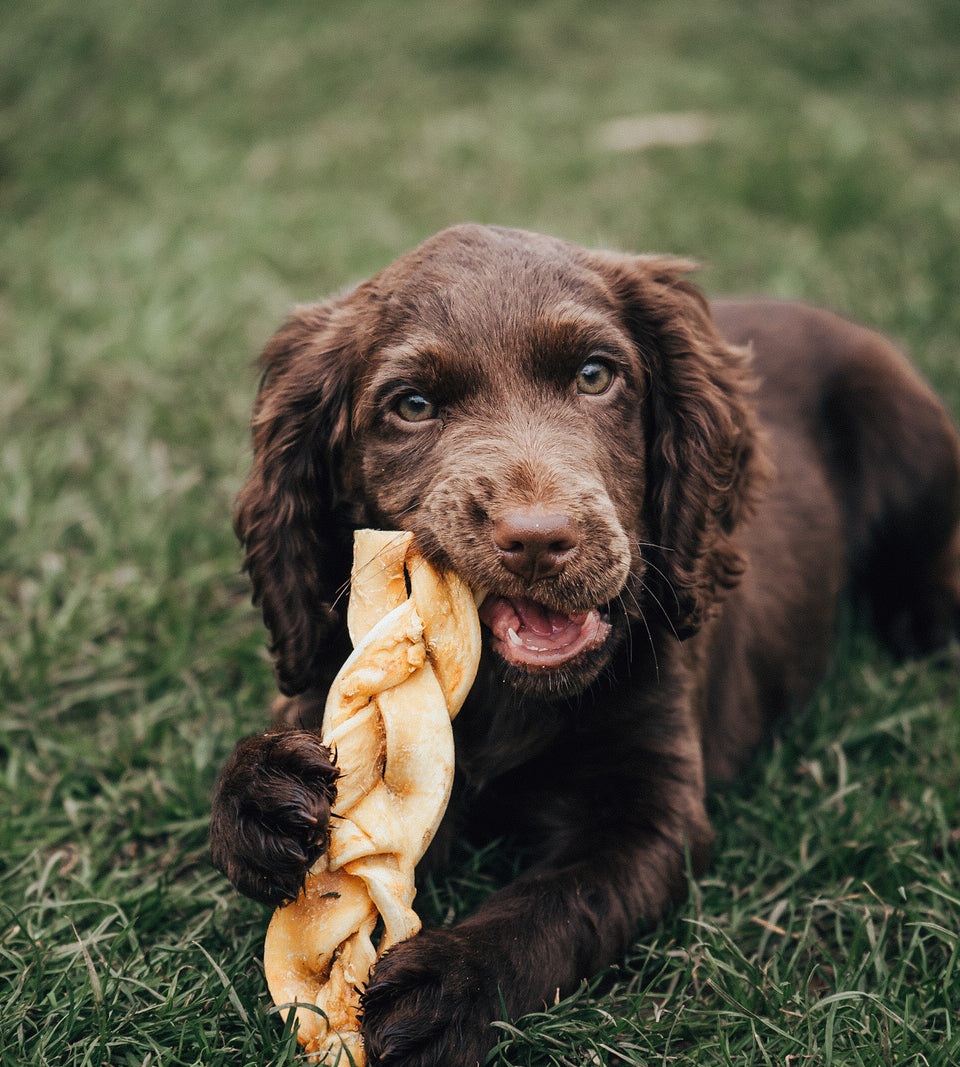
704,302,960,778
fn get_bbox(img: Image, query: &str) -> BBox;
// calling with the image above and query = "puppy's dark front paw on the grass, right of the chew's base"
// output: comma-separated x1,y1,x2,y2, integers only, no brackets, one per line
362,929,501,1067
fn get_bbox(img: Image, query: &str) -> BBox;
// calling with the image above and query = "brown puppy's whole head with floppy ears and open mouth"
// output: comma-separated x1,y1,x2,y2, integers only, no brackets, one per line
237,226,757,696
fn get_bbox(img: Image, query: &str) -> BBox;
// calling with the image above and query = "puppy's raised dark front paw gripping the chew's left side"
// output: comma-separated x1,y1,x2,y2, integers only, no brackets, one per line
210,730,338,906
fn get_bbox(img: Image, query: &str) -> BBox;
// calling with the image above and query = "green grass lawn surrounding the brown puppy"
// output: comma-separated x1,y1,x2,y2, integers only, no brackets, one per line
0,0,960,1067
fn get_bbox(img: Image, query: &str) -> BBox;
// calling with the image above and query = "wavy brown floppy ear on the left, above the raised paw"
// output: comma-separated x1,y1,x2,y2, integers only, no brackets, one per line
235,300,362,695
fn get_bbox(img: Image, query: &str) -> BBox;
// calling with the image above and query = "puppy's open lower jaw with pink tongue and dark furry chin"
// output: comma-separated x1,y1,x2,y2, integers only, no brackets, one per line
480,598,618,700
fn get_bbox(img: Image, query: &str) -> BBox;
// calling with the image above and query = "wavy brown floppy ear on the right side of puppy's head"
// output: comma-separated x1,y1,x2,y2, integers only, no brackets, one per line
603,255,767,638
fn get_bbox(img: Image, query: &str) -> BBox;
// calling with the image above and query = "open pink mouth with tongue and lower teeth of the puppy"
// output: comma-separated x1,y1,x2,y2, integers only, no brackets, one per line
480,596,610,667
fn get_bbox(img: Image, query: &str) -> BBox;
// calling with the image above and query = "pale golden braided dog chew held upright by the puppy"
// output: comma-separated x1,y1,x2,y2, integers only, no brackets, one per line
263,530,480,1065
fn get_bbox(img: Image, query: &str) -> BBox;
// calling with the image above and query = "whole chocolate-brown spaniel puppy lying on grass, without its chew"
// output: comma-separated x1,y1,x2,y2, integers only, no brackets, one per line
212,220,960,1067
